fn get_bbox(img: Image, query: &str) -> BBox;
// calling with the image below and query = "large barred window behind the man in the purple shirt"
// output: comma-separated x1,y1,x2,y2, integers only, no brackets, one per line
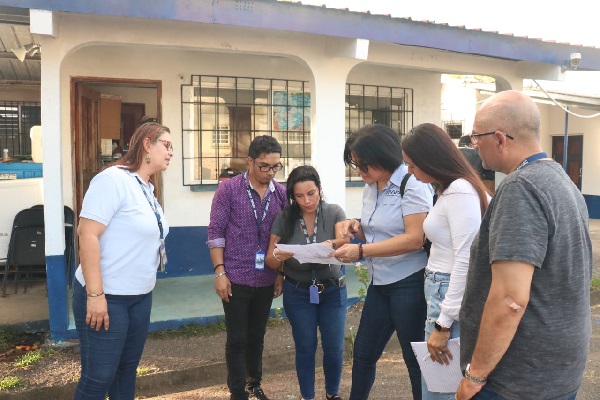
181,75,311,185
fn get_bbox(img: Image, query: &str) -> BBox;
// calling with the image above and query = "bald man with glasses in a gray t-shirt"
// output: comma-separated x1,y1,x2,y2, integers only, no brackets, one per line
457,91,592,400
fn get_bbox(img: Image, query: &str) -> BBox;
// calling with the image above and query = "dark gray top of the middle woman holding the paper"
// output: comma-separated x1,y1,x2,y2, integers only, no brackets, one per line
271,202,346,282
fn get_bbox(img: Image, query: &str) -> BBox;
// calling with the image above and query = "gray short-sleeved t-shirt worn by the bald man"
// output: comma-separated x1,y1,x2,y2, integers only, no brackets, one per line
460,161,593,400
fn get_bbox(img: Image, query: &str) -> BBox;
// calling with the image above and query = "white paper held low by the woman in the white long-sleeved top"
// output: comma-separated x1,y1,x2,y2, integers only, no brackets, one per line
410,338,463,393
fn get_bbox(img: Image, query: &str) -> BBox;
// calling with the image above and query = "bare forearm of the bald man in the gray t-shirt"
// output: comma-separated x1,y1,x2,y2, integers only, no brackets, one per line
456,261,535,400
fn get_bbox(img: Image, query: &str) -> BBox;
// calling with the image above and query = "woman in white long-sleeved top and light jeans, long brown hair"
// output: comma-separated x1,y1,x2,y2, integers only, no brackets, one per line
402,124,489,399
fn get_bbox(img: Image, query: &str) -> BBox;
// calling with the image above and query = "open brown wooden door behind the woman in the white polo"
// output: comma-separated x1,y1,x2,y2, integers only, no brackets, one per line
74,82,102,213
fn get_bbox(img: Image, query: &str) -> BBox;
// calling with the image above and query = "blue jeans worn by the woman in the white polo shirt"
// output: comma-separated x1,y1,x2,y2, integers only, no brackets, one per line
73,279,152,400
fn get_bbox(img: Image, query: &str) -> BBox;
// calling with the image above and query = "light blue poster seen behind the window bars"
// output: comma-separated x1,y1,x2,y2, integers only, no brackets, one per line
273,90,310,131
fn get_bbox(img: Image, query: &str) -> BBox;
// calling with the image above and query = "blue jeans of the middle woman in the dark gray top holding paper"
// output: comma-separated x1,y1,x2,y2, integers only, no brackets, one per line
283,281,347,399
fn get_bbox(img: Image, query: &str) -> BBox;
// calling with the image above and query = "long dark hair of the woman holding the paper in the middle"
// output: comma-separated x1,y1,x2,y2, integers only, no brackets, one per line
281,165,326,243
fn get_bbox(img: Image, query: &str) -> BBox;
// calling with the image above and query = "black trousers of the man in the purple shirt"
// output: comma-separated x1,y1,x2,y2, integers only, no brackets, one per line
223,283,273,399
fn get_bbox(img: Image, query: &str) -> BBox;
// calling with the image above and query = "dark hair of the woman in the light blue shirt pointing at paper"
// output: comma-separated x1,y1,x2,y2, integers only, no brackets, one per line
344,124,403,172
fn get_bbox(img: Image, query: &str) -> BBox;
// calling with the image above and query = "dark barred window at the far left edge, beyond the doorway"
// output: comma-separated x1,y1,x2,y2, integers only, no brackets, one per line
0,101,41,158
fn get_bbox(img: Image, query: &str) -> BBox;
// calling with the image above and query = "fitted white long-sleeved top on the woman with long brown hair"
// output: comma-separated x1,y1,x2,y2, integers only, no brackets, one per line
423,179,481,326
